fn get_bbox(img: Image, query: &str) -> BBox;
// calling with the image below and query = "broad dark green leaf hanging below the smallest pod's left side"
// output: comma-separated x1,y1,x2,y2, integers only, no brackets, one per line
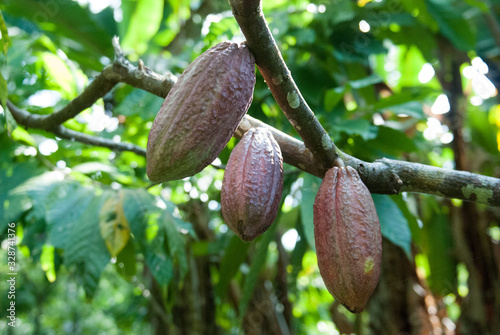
215,235,251,299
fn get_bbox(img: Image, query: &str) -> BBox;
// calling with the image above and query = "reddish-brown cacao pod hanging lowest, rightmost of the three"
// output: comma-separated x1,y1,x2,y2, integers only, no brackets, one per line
314,166,382,313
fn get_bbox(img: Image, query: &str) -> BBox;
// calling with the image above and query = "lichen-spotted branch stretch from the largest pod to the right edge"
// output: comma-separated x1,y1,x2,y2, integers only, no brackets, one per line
235,115,500,206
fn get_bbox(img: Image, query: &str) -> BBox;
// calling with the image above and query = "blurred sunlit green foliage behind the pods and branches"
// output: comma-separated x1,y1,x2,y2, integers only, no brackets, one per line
0,0,500,334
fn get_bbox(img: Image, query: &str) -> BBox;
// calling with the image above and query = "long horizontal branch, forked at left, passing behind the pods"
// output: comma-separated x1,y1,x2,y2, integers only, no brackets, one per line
7,36,500,206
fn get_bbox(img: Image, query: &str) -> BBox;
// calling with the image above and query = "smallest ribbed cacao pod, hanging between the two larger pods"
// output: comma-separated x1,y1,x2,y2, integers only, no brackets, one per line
221,128,283,241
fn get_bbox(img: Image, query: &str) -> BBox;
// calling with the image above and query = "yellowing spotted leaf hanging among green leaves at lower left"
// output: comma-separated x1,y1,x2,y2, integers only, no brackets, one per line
99,192,130,257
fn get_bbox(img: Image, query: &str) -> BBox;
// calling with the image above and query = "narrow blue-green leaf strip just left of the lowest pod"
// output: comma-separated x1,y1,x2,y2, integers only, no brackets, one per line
300,173,322,250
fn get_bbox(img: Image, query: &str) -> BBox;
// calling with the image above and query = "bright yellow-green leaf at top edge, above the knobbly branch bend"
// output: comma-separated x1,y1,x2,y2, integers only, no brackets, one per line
122,0,164,55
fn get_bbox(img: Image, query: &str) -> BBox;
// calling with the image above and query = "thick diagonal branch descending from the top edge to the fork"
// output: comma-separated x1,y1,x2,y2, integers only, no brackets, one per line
229,0,340,171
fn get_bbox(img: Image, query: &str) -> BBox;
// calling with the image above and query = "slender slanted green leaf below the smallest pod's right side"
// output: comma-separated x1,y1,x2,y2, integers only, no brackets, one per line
238,224,278,315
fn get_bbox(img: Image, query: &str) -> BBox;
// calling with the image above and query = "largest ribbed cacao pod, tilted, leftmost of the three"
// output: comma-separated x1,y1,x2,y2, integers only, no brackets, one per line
146,42,255,182
